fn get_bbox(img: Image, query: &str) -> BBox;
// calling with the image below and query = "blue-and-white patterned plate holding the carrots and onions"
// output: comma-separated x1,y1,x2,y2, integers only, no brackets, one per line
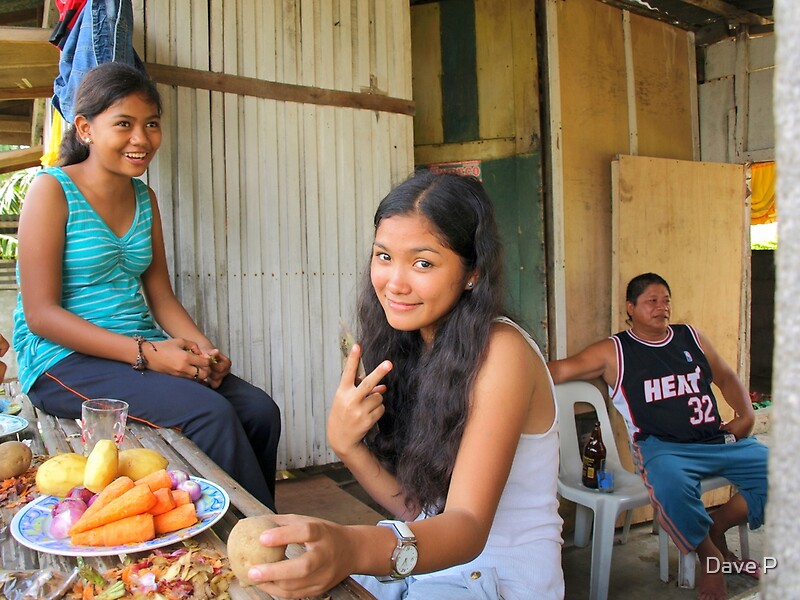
11,477,230,556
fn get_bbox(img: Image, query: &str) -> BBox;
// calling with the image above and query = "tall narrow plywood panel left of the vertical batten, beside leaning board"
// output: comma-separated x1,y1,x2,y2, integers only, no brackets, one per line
553,0,629,354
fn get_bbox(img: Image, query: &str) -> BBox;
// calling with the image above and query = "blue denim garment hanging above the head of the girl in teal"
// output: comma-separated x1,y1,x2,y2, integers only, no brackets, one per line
53,0,144,124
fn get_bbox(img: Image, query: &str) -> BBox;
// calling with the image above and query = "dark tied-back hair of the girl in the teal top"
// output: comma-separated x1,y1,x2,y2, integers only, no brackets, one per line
58,62,161,167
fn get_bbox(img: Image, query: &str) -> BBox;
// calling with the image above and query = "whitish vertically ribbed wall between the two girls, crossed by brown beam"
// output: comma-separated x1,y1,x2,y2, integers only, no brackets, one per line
134,0,413,468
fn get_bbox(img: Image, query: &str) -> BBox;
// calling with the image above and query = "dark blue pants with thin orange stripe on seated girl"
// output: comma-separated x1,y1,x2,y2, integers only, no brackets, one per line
28,353,281,511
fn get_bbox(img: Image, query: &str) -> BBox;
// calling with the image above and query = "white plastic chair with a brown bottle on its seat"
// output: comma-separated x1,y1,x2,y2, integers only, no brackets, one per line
556,381,652,600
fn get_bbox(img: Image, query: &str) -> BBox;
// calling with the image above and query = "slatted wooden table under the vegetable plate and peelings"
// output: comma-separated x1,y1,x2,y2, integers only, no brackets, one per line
0,401,374,600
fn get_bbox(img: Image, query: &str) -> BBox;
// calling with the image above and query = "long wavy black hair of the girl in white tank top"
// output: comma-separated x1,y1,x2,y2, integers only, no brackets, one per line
359,172,505,513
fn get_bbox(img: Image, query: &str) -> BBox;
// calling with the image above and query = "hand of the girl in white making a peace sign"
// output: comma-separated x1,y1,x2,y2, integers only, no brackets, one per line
328,344,392,457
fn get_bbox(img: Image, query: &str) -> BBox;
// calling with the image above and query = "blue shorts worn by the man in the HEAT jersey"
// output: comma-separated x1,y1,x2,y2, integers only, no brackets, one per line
633,435,769,553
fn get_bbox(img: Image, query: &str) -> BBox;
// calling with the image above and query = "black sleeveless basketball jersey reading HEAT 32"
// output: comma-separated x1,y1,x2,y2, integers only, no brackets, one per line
611,325,724,443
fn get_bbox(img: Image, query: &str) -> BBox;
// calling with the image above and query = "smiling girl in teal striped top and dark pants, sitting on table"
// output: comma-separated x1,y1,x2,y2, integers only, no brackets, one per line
13,63,280,510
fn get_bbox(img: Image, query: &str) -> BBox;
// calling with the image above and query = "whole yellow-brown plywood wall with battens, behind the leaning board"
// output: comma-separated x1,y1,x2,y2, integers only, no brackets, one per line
546,0,700,358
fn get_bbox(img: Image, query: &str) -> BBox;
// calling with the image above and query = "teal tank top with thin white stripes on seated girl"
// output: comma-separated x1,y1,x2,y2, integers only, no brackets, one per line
13,167,166,392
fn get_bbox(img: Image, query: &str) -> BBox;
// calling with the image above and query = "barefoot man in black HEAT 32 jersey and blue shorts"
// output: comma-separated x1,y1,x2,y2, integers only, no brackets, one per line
548,273,768,600
